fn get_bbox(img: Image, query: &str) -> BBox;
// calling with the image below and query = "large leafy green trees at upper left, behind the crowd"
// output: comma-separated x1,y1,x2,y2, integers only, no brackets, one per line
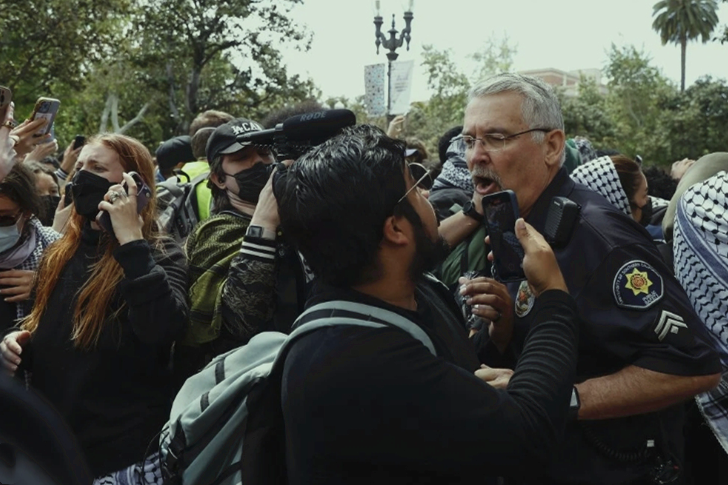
0,0,320,149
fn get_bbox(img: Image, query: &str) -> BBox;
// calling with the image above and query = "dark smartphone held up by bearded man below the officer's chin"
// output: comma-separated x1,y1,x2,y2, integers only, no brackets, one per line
483,190,526,283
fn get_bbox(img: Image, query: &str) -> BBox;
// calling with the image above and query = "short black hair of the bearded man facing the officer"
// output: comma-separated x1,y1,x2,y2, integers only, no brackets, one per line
274,125,422,287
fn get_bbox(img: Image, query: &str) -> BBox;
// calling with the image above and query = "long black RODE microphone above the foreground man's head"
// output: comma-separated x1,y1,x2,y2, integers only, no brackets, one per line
237,109,356,146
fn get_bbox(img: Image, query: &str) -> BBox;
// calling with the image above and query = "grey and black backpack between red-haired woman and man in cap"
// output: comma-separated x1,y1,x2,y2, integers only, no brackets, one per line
157,170,210,244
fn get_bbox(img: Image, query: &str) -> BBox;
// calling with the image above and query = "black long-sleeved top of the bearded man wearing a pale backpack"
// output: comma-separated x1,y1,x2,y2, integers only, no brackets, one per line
283,291,578,477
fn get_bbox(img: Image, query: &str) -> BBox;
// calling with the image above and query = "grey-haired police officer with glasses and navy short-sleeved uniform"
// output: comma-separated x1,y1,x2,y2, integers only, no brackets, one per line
461,74,720,485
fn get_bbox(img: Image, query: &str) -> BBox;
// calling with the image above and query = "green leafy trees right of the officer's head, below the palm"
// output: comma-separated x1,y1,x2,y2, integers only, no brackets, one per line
562,45,728,165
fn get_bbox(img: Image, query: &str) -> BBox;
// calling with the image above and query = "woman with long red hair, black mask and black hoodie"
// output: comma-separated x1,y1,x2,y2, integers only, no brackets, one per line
0,131,188,483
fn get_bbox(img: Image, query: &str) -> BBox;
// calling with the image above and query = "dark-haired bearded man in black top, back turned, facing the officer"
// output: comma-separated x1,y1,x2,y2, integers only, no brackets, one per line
274,125,578,484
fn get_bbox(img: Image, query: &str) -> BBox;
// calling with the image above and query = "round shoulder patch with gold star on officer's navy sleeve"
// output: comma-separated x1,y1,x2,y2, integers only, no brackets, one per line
612,260,664,310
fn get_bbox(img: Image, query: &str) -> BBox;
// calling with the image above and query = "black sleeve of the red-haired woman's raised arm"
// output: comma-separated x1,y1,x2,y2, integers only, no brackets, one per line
114,239,189,344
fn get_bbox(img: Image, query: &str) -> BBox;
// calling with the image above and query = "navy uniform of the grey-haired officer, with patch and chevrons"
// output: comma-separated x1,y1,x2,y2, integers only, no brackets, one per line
508,168,721,484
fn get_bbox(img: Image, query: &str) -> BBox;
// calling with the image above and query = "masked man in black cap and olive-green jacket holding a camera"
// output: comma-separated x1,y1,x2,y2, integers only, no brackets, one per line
175,118,303,384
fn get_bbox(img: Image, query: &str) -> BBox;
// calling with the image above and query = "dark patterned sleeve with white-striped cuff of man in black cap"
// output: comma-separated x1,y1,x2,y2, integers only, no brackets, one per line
221,236,276,345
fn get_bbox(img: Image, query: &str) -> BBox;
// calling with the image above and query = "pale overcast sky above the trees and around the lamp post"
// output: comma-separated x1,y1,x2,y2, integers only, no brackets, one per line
284,0,728,101
